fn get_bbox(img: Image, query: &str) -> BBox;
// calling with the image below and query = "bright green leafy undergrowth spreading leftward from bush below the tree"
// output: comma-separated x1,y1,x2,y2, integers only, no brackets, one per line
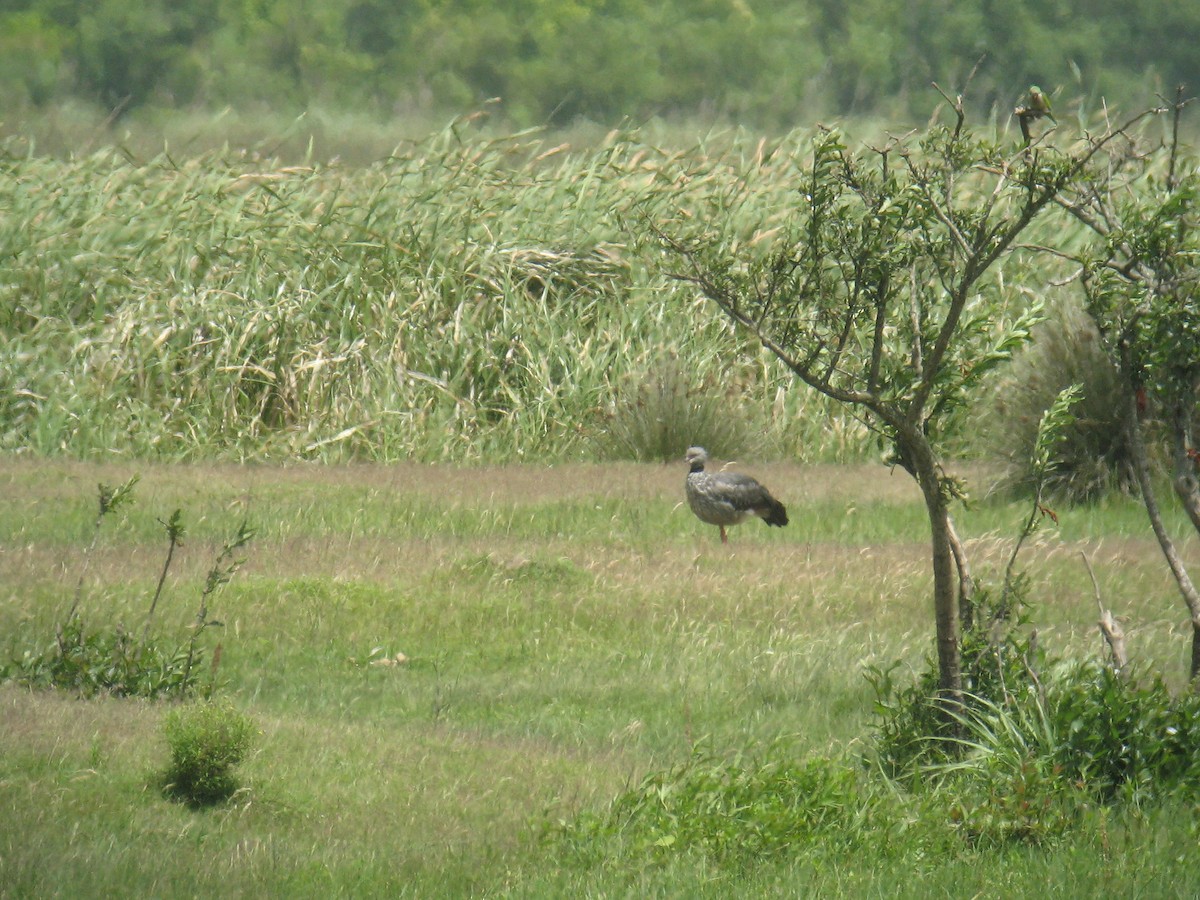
547,664,1200,870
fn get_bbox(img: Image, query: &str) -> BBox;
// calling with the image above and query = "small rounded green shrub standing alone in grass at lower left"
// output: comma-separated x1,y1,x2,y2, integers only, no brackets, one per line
163,701,254,805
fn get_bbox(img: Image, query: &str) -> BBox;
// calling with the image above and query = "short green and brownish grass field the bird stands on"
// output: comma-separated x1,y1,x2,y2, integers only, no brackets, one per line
0,458,1200,898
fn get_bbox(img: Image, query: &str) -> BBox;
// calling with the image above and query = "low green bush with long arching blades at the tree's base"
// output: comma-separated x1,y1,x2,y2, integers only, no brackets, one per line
922,662,1200,845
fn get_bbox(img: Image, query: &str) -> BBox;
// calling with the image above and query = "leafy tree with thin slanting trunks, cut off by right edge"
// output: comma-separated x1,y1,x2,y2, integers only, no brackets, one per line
1060,88,1200,690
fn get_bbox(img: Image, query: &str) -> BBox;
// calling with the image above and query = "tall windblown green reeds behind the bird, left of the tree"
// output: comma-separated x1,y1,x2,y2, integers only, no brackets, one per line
0,124,863,461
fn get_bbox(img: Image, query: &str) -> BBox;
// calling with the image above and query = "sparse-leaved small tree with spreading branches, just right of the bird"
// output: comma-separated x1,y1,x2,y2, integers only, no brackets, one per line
664,96,1147,703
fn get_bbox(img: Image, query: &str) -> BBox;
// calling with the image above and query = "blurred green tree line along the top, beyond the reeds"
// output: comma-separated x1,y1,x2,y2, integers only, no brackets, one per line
0,0,1200,127
